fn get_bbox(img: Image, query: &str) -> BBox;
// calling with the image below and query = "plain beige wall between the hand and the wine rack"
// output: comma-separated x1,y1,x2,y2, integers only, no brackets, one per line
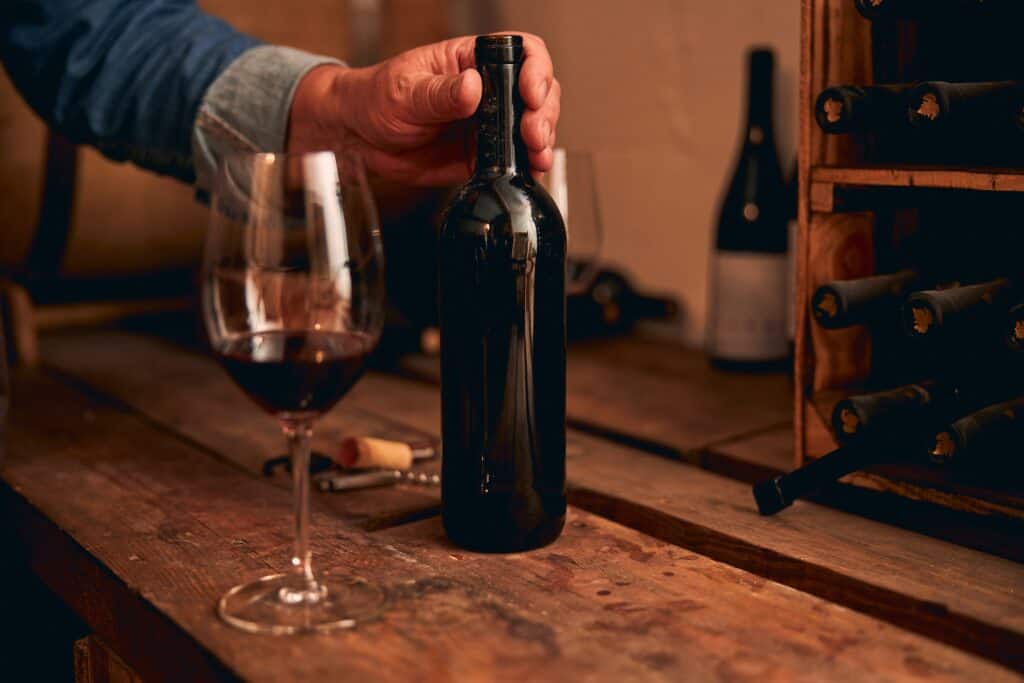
490,0,800,344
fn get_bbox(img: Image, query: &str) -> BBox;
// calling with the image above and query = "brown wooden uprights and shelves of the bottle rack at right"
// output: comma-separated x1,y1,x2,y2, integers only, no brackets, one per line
795,0,1024,520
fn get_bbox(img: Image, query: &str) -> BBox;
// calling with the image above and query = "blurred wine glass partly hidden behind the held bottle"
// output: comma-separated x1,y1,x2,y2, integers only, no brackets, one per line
541,147,603,296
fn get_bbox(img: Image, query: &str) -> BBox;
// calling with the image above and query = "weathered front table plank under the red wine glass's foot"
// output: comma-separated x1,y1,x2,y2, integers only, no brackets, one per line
3,368,1013,681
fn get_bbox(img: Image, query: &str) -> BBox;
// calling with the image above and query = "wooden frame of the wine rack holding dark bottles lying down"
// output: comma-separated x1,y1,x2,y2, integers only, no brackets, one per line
795,0,1024,519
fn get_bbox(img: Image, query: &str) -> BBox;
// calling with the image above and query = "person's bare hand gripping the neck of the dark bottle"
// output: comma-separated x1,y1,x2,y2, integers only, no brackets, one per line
287,34,561,185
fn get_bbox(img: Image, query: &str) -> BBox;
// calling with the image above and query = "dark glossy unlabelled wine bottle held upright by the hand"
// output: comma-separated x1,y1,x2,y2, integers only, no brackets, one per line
438,36,566,552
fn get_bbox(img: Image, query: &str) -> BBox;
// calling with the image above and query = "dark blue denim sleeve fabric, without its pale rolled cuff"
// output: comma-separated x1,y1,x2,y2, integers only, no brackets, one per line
0,0,258,180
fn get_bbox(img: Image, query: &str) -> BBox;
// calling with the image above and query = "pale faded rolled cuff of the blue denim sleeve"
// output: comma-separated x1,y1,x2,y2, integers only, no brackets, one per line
191,45,344,199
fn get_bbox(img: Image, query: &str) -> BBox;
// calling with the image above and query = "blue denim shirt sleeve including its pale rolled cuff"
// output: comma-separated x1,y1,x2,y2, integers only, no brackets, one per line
0,0,344,187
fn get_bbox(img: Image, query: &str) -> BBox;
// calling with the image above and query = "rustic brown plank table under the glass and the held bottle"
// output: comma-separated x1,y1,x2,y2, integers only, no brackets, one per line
0,331,1024,681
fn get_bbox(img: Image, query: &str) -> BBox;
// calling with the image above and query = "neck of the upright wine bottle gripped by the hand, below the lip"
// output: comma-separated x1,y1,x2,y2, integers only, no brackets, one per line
476,62,529,177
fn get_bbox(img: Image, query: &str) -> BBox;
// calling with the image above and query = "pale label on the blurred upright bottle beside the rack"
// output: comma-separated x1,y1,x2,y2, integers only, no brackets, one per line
708,252,790,360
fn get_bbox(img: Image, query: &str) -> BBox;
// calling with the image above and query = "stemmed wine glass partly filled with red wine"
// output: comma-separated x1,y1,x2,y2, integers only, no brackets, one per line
202,152,384,634
